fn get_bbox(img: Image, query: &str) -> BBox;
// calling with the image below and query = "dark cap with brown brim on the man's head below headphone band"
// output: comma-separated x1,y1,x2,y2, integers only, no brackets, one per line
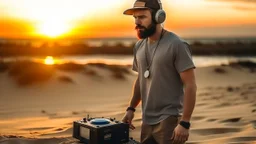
123,0,161,15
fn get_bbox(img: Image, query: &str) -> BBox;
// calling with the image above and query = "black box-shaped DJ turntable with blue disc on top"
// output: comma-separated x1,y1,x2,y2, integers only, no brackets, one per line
73,116,136,144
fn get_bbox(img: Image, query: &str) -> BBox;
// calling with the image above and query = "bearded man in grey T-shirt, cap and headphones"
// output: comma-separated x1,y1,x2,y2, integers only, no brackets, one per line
122,0,196,144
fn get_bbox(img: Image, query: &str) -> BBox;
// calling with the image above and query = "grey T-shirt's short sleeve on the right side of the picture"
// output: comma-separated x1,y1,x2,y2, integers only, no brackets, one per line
174,42,195,73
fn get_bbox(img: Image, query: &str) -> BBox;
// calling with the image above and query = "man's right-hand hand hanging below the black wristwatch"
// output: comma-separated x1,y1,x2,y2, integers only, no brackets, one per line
172,124,189,144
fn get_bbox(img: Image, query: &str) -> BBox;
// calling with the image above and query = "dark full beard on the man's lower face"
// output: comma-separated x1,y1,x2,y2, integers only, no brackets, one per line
135,22,156,39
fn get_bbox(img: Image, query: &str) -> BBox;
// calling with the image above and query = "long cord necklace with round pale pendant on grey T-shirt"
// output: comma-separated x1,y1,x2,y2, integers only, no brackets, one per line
144,29,164,78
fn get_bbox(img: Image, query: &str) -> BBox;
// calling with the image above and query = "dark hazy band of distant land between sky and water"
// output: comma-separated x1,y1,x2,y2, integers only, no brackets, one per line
0,38,256,57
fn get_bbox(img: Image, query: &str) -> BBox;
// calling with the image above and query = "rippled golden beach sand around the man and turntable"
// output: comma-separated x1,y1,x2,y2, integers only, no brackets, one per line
0,60,256,144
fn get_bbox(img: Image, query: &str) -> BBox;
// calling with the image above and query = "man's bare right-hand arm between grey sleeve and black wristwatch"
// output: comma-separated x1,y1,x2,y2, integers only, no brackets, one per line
180,68,197,122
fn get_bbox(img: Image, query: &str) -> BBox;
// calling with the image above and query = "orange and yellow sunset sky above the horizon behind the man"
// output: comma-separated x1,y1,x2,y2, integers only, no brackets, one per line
0,0,256,38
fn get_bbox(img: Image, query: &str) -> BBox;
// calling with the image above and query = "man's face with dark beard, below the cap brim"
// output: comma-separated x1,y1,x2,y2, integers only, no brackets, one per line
133,10,156,39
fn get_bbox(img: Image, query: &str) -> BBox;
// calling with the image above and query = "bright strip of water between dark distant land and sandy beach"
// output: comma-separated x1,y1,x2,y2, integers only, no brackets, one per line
3,55,256,67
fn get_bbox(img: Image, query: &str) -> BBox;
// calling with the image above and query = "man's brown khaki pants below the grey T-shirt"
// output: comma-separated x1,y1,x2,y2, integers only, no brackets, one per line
141,116,180,144
